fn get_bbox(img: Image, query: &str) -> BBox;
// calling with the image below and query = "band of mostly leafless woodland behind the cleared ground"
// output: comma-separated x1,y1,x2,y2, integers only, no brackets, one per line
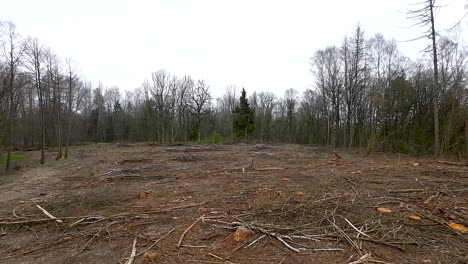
0,1,468,168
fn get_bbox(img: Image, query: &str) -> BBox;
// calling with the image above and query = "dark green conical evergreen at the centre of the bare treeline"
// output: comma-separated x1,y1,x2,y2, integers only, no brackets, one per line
233,89,255,142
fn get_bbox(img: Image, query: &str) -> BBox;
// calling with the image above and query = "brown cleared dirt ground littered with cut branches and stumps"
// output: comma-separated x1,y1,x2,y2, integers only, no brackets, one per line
0,144,468,264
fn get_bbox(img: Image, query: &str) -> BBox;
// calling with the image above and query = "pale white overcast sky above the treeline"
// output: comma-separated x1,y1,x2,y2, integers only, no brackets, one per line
0,0,468,97
